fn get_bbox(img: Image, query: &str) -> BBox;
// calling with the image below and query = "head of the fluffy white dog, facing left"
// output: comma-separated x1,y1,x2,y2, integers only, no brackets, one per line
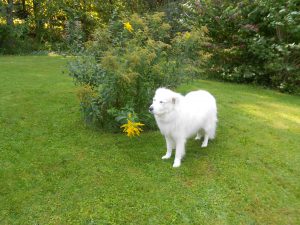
149,88,180,116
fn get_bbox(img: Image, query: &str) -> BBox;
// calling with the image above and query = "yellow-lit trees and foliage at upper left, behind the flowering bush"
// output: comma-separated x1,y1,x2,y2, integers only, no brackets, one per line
0,0,172,54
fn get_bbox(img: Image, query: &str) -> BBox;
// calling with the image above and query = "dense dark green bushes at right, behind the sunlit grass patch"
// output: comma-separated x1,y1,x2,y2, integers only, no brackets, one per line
186,0,300,93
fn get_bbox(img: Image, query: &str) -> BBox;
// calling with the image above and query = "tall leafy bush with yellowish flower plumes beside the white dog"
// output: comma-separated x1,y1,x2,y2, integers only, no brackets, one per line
70,13,209,129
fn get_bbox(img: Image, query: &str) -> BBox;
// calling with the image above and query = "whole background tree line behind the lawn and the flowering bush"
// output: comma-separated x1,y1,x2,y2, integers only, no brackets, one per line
0,0,300,93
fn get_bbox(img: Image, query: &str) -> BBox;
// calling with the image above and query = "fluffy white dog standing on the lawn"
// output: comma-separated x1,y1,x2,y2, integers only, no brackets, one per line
149,88,217,167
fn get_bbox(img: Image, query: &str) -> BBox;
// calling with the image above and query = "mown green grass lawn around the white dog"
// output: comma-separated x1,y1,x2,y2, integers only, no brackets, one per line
0,56,300,225
